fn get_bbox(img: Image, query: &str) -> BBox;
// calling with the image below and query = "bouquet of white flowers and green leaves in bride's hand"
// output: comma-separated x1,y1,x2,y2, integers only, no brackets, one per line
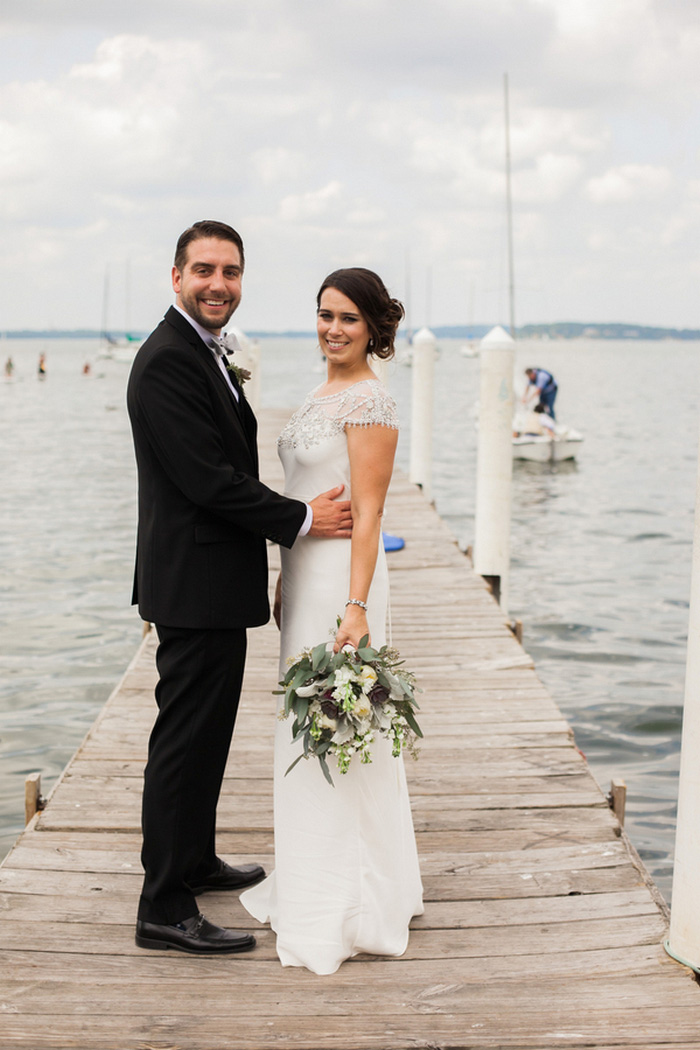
276,635,423,784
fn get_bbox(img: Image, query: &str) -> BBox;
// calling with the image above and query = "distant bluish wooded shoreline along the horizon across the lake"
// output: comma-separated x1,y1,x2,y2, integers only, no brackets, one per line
0,321,700,347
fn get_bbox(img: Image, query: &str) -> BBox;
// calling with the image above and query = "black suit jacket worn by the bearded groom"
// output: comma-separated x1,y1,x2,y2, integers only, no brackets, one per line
127,308,306,628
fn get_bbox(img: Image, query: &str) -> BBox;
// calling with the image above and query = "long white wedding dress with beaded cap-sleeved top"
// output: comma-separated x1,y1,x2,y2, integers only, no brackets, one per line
240,379,423,973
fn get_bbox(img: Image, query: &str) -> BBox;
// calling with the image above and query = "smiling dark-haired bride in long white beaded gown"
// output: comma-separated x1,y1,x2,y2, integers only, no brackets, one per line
240,268,423,973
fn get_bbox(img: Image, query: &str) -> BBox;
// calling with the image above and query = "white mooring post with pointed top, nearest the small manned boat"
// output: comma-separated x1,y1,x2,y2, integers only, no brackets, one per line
473,326,515,615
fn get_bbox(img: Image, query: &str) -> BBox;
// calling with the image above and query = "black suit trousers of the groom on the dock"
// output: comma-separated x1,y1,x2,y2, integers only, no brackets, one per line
139,625,247,923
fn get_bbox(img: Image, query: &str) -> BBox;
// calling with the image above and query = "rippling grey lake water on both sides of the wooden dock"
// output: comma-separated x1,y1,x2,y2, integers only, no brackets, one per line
0,331,700,899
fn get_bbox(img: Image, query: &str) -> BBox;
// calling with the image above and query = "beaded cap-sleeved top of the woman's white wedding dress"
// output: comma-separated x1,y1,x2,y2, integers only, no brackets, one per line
277,379,399,450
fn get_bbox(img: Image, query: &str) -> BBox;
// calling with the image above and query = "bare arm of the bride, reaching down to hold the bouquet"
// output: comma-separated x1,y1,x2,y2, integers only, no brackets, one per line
335,426,399,652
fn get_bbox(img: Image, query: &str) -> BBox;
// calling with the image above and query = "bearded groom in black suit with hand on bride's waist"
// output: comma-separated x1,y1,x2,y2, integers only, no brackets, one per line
127,222,352,954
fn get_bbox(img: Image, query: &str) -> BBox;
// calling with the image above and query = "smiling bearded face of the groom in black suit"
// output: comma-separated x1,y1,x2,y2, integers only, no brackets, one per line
172,237,243,334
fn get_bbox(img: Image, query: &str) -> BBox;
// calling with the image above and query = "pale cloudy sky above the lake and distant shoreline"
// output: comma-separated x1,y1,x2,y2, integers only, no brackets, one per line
0,0,700,330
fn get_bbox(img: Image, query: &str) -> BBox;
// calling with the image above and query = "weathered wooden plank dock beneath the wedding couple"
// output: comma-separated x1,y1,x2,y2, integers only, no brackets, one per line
0,403,700,1050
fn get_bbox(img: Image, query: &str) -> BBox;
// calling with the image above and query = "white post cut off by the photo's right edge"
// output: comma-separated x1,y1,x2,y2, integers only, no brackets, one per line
665,428,700,973
